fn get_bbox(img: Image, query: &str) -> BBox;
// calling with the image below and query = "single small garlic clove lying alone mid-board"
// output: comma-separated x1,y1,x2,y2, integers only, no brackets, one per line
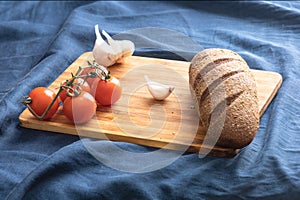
144,75,175,100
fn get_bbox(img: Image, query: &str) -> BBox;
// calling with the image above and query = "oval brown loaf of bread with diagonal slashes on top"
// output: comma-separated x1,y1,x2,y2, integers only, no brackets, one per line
189,48,259,148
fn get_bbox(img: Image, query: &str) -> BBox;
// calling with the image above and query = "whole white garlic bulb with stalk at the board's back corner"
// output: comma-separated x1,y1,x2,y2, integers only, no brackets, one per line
93,24,134,67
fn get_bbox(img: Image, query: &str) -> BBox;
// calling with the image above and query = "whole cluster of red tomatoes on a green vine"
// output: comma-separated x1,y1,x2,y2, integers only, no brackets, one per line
23,61,122,124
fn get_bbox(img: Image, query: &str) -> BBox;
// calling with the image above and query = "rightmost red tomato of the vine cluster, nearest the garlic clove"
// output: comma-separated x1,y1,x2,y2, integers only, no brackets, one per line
91,77,122,106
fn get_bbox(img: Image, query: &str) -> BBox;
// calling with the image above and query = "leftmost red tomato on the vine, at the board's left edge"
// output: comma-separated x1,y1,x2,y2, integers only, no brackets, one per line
28,87,59,119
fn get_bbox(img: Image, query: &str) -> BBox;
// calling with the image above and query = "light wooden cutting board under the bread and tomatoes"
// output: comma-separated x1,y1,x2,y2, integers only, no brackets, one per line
19,52,282,157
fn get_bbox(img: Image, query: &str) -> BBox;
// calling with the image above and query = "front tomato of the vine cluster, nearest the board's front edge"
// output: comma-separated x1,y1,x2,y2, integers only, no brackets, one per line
63,91,97,124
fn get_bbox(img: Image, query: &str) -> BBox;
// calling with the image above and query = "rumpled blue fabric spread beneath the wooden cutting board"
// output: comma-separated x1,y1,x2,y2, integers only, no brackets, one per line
0,1,300,199
